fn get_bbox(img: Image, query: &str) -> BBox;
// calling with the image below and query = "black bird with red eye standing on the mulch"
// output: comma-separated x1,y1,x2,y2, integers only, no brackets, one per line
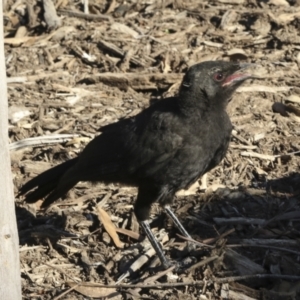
20,61,252,268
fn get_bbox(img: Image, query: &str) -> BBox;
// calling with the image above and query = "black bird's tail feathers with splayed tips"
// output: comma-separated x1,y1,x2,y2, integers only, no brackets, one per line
19,157,78,207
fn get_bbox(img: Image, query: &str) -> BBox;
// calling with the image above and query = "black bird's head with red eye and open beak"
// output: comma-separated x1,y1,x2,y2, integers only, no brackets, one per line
179,61,253,108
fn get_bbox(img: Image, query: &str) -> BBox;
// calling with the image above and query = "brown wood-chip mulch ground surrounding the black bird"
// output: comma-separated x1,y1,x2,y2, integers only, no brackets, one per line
4,0,300,300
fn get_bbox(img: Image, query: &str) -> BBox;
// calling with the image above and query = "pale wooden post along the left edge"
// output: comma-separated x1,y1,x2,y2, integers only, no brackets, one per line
0,1,22,300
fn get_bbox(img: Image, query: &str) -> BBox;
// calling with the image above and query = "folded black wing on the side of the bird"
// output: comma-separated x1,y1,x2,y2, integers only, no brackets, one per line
74,100,183,181
